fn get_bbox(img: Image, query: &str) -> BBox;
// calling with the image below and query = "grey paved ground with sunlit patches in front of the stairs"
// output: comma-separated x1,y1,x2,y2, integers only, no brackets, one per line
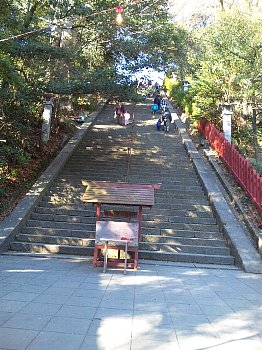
0,255,262,350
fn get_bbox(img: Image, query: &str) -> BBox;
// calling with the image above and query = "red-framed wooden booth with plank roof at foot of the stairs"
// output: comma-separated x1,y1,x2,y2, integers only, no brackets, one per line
82,181,160,274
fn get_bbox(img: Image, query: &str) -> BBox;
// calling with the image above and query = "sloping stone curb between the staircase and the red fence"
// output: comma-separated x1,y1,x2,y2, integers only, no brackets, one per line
168,103,262,274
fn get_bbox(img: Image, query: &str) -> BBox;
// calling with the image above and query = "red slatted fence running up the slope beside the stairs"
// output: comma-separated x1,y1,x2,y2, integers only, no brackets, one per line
198,120,262,214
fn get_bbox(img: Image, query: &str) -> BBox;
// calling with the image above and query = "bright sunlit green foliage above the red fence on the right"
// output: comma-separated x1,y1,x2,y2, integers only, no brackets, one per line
168,5,262,155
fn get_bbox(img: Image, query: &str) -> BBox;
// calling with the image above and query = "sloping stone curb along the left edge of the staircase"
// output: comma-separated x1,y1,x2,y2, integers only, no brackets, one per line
0,101,107,253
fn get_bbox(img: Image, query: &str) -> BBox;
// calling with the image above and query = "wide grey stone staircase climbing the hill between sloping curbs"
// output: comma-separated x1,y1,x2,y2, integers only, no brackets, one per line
10,102,234,264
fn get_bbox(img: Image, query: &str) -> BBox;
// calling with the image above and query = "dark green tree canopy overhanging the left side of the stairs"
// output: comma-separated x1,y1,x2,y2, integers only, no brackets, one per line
0,0,181,189
